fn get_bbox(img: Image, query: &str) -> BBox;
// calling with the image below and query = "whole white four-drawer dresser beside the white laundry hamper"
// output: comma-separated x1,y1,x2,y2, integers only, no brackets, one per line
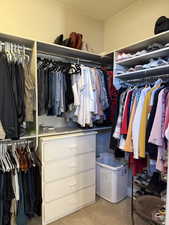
39,132,96,225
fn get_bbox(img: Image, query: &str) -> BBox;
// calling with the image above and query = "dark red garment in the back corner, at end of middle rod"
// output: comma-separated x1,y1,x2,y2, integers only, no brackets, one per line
106,71,118,121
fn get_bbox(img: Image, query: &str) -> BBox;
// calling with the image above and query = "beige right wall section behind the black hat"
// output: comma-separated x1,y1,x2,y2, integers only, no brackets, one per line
104,0,169,51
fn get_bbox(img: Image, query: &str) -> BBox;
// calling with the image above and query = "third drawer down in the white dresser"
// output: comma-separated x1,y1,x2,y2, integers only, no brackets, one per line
44,169,96,202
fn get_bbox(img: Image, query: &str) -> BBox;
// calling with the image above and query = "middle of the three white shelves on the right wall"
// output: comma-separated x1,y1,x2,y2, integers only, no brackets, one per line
116,47,169,66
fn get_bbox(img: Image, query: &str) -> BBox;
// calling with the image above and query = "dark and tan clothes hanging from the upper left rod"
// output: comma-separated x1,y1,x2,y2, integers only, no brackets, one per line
0,44,35,139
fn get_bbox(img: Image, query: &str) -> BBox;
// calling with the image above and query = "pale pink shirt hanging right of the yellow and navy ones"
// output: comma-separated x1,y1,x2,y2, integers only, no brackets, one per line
148,89,165,146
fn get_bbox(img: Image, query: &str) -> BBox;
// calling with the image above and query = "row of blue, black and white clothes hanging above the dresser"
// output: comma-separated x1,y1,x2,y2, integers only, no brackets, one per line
38,58,112,127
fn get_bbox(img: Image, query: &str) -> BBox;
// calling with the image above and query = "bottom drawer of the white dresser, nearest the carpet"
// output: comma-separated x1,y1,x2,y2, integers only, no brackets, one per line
43,186,95,223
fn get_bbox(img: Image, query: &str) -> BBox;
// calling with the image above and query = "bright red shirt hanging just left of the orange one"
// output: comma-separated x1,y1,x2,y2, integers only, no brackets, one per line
120,91,133,134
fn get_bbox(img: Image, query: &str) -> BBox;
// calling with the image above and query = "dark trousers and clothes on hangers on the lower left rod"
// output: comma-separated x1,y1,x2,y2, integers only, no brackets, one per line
0,141,42,225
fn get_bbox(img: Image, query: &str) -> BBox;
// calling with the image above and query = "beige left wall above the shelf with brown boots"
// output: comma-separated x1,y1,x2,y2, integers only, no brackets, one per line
0,0,104,52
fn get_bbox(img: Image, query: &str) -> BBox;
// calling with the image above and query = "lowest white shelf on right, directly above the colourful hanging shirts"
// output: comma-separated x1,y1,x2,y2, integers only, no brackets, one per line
115,65,169,79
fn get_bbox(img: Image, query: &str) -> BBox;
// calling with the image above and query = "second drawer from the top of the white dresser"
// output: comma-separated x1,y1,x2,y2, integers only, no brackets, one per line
43,152,96,183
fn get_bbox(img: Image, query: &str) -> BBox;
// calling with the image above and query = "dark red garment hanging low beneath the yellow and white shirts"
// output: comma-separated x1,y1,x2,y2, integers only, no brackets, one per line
129,153,147,176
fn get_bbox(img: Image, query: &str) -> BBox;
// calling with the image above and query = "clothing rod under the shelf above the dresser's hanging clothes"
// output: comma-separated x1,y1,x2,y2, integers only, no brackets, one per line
38,51,101,65
